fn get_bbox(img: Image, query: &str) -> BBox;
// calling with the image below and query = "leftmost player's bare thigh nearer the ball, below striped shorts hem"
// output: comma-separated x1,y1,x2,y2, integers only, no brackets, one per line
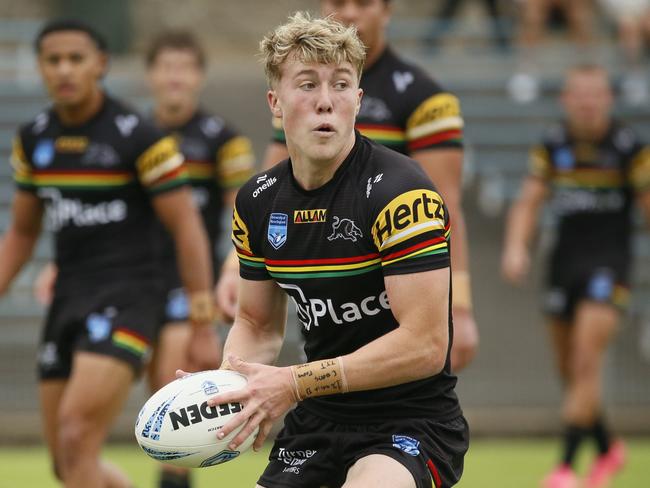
58,351,134,440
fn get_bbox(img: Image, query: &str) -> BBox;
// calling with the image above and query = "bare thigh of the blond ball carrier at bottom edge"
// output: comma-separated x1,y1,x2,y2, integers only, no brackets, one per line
343,454,416,488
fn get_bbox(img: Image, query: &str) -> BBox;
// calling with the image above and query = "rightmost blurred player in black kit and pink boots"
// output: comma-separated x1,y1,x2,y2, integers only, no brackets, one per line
502,66,650,488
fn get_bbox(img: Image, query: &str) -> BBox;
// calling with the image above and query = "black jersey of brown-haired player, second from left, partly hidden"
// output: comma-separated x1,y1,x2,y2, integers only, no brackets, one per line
152,111,255,271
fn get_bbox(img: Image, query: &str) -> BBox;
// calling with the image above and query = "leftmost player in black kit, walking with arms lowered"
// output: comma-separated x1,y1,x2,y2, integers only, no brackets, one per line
0,20,218,488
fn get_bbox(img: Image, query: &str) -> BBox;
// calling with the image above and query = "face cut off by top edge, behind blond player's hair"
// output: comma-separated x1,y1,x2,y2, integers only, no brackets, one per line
321,0,390,50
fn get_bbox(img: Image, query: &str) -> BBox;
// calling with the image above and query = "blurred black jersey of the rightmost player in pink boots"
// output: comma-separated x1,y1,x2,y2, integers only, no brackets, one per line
529,122,650,260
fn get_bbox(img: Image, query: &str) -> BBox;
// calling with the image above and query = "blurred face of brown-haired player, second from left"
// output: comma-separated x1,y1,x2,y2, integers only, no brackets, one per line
147,48,204,106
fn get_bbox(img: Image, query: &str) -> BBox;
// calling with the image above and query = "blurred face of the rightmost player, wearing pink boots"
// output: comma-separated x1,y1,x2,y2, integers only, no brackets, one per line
562,71,613,126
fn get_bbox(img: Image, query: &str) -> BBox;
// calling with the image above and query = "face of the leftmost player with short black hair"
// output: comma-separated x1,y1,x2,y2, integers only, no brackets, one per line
38,31,107,107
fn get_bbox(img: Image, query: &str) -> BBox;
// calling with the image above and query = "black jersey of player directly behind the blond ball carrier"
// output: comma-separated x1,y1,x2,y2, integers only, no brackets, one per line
273,48,463,154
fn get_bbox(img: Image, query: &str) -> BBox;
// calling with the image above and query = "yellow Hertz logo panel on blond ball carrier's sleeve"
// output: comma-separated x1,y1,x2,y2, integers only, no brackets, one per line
372,189,445,251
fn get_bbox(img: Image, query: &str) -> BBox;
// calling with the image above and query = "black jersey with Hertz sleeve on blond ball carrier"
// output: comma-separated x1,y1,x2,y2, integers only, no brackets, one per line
232,134,460,422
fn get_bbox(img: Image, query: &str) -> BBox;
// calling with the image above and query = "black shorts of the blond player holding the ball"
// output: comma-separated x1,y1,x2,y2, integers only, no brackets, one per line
258,406,469,488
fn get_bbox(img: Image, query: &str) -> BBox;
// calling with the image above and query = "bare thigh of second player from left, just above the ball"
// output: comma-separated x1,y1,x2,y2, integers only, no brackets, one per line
149,322,187,390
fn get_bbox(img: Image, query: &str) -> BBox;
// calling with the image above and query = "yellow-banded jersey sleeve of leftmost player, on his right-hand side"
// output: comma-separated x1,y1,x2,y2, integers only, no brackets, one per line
134,124,188,195
